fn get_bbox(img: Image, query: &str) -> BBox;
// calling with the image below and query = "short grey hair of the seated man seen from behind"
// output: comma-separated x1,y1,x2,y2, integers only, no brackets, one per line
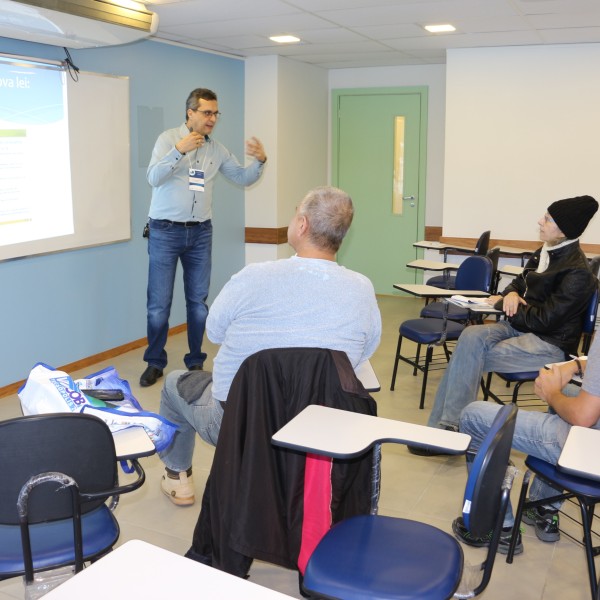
298,186,354,252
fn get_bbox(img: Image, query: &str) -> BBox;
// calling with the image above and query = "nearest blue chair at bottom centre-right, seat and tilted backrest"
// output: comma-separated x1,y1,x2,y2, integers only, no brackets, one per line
303,405,517,600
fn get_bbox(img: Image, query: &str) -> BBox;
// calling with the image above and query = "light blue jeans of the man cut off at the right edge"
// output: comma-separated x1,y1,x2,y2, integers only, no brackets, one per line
460,400,579,527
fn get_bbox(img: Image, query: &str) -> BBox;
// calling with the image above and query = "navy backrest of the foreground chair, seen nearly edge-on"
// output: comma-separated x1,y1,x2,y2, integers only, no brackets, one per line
463,403,518,537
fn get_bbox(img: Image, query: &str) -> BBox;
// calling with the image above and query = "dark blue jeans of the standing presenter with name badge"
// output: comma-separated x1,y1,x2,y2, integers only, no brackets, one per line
144,219,212,369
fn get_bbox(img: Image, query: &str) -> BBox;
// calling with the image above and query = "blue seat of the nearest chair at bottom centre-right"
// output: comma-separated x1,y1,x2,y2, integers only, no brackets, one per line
304,515,463,600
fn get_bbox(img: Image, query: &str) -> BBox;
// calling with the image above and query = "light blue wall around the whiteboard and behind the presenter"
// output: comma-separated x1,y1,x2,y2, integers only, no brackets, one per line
0,38,244,387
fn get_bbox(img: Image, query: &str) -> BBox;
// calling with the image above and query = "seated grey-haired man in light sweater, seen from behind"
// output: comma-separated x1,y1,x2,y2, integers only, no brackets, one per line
160,187,381,506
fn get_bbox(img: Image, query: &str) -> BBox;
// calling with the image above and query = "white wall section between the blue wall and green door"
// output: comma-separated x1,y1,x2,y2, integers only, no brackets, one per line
245,56,329,263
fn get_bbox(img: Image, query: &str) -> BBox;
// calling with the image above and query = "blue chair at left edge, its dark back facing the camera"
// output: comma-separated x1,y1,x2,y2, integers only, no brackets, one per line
0,413,145,583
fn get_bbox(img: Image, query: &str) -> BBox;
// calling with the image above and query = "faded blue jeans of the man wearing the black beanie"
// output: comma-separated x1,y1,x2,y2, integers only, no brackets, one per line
427,321,565,428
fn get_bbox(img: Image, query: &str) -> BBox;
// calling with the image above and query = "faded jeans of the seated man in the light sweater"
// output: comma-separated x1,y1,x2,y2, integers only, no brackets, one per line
159,371,223,473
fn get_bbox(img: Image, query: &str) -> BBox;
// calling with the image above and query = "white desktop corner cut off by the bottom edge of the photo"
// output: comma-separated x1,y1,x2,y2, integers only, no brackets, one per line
44,540,291,600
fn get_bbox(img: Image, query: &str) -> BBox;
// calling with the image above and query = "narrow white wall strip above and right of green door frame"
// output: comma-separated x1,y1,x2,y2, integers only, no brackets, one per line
328,65,446,226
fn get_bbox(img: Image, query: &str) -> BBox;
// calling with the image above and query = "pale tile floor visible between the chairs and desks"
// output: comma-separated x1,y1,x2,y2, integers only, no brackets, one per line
0,296,590,600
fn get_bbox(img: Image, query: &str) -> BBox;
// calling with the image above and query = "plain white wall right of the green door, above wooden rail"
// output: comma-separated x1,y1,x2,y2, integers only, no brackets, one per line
443,44,600,244
